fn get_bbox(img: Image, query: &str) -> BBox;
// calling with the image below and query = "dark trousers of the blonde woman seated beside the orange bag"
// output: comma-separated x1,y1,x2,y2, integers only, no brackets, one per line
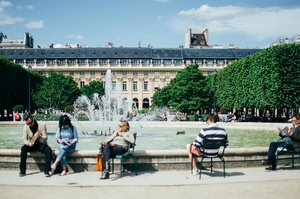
102,144,127,171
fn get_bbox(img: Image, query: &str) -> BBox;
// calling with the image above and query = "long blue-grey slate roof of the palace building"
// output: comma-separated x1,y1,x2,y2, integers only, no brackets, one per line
0,47,261,59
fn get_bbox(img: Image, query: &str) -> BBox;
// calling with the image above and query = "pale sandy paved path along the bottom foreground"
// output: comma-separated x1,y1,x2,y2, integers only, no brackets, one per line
0,166,300,199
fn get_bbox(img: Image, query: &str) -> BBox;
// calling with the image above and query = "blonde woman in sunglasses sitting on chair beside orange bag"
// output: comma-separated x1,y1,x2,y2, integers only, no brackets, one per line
100,120,134,179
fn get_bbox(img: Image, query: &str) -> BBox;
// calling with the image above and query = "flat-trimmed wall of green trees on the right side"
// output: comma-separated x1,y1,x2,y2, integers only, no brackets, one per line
217,44,300,108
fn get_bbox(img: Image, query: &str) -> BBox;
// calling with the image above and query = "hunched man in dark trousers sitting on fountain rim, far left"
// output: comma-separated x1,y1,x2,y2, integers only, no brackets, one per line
19,115,52,177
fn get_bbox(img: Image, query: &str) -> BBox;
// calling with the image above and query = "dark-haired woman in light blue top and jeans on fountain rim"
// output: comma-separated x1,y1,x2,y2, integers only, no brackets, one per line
51,115,78,176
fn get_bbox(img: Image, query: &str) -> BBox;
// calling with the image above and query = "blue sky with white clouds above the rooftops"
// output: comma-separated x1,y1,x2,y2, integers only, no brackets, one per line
0,0,300,48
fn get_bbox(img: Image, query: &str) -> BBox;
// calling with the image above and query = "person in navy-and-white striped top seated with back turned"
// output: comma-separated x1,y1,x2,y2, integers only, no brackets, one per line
187,115,227,174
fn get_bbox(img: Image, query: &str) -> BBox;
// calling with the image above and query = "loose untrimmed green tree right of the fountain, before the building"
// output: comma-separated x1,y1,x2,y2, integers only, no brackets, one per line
152,64,210,113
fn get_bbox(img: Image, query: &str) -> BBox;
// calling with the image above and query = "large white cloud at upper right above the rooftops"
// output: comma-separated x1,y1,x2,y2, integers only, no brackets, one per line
172,5,300,40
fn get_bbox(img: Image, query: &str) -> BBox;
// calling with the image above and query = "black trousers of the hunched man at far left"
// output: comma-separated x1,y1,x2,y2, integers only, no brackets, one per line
20,142,52,174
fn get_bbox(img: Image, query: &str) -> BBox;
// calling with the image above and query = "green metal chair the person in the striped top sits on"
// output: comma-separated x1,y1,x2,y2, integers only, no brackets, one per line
191,138,228,179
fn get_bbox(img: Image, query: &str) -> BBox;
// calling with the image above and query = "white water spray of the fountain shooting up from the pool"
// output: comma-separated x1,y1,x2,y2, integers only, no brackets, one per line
74,70,134,135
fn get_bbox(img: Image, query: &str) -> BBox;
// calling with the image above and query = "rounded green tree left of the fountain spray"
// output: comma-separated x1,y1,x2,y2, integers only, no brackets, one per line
33,71,80,110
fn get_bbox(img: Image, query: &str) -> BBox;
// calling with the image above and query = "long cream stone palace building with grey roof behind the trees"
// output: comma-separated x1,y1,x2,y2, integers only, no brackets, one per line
0,30,260,109
